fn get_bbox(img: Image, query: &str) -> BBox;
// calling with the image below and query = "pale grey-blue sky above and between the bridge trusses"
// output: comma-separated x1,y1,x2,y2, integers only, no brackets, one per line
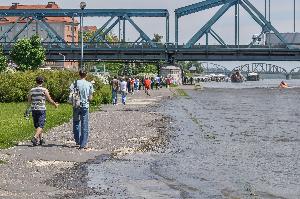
0,0,300,69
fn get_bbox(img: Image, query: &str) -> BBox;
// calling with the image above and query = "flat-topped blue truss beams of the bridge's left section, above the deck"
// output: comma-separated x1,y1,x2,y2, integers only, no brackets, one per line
0,9,169,47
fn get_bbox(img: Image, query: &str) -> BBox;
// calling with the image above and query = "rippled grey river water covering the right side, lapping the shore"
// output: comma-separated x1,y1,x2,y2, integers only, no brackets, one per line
87,81,300,199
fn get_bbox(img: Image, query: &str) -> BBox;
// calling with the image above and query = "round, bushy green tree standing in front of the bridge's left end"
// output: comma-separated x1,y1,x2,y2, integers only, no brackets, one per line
10,35,46,71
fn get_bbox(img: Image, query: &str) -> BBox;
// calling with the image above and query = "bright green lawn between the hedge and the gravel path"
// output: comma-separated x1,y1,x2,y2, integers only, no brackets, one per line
0,103,72,149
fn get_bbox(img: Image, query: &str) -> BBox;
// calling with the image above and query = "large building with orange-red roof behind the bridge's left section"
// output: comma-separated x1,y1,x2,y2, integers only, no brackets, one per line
0,1,79,68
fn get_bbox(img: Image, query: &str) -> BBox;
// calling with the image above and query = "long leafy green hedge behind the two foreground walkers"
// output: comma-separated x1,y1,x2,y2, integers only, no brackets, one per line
0,71,111,105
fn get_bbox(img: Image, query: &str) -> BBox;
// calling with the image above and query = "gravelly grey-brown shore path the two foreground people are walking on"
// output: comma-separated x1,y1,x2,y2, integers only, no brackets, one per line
0,88,173,199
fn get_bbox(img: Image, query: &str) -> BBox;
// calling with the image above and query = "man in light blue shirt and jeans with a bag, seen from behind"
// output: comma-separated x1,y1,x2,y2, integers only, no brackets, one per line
70,70,94,149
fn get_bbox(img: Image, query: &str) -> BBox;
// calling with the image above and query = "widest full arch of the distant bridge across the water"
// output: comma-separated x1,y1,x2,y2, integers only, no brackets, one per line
232,63,289,75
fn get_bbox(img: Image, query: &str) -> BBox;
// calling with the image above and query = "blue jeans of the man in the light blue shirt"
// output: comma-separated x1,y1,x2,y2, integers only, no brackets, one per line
73,107,89,148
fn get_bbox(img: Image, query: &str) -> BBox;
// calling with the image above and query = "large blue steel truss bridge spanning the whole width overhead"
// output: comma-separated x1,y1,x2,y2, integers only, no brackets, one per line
0,0,300,63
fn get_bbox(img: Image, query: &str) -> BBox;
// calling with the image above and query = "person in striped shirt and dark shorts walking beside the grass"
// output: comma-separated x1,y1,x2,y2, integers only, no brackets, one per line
27,76,58,146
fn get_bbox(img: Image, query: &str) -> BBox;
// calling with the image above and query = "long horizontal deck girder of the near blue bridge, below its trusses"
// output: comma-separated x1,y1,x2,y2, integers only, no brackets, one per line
3,43,300,62
